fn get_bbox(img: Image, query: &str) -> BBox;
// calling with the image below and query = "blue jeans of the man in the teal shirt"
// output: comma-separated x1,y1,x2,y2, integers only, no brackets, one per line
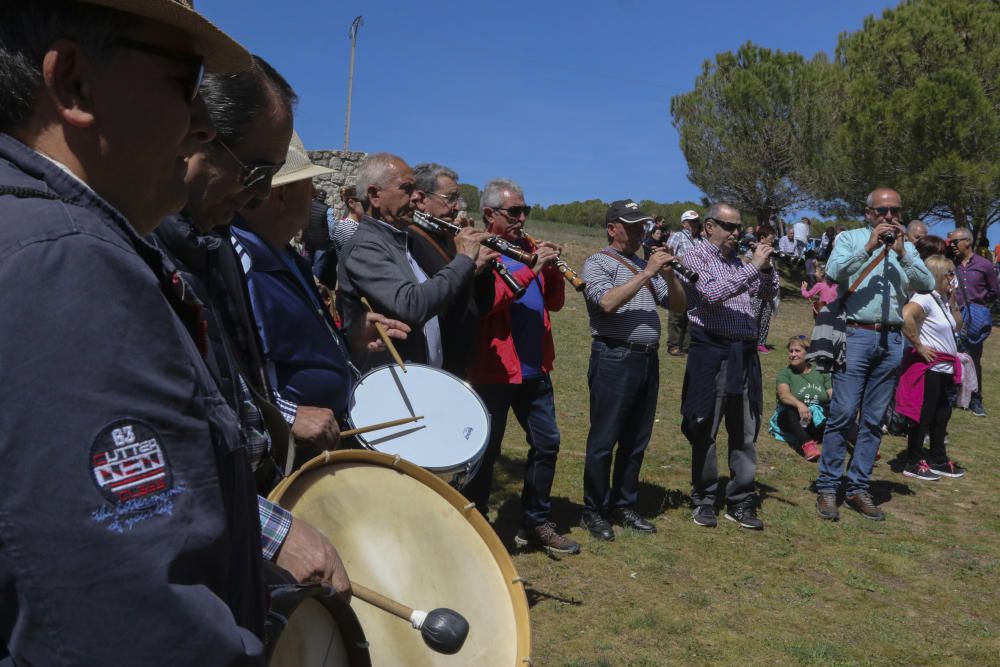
816,327,903,494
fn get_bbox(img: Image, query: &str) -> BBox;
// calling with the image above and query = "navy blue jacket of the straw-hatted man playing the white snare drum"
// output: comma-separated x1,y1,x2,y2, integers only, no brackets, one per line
233,227,353,420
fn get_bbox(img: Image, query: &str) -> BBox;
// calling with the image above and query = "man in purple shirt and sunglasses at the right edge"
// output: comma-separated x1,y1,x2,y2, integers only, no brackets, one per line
948,227,1000,417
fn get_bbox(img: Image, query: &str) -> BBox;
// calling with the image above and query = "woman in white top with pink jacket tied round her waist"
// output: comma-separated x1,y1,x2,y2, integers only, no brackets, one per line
897,255,965,481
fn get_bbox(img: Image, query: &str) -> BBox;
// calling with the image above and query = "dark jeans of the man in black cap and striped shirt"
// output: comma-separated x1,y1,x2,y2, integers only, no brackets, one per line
583,340,660,516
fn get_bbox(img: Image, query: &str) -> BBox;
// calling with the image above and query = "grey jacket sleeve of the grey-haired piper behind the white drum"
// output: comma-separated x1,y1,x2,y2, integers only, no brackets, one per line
343,236,476,327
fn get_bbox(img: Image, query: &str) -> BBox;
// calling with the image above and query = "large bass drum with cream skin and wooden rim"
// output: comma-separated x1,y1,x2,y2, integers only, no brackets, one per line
271,450,531,667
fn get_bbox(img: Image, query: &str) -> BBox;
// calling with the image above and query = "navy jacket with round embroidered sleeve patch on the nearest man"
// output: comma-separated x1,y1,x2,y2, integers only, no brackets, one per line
0,134,264,665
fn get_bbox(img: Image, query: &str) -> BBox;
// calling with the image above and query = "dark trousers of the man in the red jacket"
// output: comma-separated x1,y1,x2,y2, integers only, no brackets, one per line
463,375,559,528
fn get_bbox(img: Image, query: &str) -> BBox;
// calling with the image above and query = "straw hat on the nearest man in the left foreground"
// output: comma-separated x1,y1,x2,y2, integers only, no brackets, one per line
82,0,253,72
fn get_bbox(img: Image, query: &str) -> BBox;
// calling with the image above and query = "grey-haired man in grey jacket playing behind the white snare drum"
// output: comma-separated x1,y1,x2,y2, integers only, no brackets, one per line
338,153,486,368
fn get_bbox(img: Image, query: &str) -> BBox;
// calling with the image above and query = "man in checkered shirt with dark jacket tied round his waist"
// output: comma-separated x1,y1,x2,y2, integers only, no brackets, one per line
681,203,778,530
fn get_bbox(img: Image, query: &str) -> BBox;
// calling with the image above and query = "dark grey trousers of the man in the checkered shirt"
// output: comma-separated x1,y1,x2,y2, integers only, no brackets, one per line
681,361,760,505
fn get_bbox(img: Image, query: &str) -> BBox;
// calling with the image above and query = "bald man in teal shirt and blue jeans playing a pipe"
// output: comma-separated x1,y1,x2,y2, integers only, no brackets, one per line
816,188,934,521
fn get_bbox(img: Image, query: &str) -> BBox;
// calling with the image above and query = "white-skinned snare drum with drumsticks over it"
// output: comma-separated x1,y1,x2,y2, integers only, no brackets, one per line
348,364,490,489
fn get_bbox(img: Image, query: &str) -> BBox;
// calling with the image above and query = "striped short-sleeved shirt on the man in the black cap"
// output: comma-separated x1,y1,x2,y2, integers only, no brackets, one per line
583,247,667,344
